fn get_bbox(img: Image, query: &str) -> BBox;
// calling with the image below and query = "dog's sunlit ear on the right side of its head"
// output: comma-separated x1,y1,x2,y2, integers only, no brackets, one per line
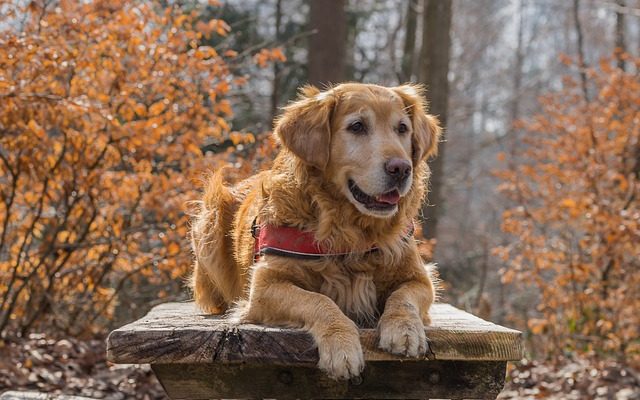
393,84,442,164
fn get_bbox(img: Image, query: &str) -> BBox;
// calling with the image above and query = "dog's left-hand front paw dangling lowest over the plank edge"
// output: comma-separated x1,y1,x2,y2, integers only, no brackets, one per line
318,329,364,379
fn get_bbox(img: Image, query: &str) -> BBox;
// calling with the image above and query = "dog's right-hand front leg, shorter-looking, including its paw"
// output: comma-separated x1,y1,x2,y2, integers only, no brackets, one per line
378,280,434,357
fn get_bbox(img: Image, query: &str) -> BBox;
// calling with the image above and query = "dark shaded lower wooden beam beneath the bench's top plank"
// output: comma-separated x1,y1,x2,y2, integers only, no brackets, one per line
152,361,506,399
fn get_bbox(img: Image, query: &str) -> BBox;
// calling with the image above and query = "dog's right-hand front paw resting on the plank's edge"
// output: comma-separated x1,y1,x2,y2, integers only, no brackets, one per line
378,315,428,358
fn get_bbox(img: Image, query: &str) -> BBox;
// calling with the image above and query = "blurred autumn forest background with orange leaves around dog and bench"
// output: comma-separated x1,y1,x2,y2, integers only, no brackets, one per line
0,0,640,399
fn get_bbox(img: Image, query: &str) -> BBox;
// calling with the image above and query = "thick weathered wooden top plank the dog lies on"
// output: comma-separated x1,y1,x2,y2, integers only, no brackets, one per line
107,303,523,365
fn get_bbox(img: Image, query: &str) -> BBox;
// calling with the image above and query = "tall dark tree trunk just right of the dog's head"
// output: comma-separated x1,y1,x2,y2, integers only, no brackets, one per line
420,0,452,239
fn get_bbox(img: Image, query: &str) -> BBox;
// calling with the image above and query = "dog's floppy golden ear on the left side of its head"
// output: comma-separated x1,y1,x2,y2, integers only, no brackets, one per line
274,86,336,171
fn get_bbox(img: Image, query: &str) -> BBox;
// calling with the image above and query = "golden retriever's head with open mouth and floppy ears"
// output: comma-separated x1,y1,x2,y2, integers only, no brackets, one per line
275,83,440,218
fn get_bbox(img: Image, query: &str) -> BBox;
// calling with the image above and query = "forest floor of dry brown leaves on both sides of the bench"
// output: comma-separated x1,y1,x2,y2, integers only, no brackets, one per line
0,334,640,400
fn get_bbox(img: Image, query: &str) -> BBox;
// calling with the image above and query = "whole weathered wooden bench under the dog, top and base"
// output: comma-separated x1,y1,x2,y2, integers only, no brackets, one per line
107,303,523,399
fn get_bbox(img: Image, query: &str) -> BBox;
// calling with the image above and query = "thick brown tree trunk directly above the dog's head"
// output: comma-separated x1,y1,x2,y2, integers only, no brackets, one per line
308,0,347,86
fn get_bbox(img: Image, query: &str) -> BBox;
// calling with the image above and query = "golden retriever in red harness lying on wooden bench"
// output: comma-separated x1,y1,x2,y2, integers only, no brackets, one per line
191,83,440,379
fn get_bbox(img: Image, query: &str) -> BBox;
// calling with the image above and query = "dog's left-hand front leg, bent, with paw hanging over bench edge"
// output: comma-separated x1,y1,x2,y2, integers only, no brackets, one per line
245,268,364,379
